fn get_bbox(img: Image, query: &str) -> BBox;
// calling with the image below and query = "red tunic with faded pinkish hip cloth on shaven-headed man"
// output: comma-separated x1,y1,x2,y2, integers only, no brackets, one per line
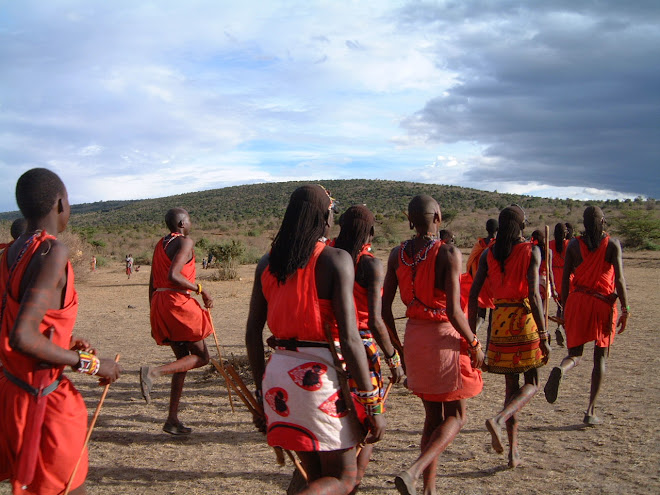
396,240,483,402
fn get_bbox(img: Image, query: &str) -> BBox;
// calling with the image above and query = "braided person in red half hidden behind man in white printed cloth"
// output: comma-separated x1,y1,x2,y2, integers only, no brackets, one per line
332,205,404,492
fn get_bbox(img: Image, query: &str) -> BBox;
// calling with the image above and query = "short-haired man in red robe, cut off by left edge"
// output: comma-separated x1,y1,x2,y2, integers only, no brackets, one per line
0,168,121,495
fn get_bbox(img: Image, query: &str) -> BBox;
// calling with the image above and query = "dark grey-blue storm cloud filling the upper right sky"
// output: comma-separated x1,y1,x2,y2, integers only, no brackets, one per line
401,2,660,197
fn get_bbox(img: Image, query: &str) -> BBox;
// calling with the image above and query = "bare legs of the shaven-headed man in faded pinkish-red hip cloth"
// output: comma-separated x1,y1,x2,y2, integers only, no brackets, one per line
395,400,466,495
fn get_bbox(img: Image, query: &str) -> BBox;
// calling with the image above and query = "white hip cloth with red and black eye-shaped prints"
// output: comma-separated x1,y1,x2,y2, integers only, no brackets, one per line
262,347,363,452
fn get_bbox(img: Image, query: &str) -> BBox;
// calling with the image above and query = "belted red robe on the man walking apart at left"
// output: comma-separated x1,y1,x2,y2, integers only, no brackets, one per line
151,238,213,345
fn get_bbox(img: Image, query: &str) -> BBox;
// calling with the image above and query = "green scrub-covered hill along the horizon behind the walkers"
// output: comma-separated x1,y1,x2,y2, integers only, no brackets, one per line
0,179,582,227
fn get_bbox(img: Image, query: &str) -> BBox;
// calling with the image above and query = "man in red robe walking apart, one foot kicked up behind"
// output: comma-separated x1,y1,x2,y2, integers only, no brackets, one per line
140,208,213,435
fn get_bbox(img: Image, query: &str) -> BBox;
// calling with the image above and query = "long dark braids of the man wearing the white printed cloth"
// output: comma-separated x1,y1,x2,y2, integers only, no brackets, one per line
268,185,332,284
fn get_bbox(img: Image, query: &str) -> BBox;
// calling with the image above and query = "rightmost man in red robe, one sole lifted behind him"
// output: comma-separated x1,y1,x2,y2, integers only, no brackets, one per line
545,206,630,426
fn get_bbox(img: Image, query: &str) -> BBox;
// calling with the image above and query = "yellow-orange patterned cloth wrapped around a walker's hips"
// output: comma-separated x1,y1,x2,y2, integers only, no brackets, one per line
486,298,544,374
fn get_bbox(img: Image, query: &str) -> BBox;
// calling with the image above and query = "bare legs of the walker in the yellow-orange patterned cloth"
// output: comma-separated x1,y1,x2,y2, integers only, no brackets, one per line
486,369,538,467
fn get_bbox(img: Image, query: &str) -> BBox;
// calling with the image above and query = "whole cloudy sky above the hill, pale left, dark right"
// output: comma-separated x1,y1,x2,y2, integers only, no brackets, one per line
0,0,660,211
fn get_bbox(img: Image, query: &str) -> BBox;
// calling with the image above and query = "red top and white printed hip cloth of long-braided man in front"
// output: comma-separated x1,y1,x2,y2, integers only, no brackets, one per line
261,242,364,452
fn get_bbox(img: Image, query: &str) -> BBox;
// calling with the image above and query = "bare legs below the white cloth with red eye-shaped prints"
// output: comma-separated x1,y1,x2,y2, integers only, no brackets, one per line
298,449,357,495
